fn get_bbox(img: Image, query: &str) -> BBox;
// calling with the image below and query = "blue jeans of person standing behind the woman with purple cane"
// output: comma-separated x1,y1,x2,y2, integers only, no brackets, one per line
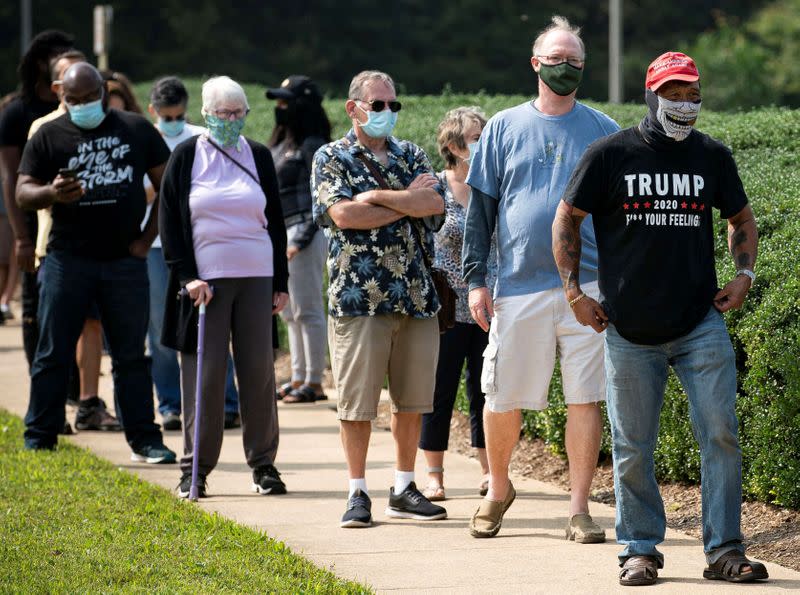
147,247,239,415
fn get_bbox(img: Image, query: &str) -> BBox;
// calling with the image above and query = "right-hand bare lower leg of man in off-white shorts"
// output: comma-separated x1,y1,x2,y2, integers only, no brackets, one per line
565,403,602,516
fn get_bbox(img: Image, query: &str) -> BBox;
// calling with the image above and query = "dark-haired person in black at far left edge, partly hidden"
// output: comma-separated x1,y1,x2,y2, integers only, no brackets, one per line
0,31,74,368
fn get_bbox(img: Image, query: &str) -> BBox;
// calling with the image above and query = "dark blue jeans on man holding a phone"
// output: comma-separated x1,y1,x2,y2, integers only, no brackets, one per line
25,251,162,449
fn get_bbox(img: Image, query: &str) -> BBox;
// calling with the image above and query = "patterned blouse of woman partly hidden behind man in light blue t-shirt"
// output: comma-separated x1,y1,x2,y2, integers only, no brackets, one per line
433,172,497,324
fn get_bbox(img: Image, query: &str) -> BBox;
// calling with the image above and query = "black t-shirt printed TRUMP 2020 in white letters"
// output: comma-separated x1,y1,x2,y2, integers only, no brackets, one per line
563,126,747,345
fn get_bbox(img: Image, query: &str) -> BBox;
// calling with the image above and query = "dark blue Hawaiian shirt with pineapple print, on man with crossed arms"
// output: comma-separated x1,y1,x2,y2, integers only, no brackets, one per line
311,129,444,318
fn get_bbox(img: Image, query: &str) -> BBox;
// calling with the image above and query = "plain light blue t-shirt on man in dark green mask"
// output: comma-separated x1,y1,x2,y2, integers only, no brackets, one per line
467,101,619,297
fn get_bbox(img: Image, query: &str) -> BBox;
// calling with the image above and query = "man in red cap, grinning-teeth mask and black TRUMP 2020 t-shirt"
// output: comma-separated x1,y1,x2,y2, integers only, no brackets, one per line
553,52,768,585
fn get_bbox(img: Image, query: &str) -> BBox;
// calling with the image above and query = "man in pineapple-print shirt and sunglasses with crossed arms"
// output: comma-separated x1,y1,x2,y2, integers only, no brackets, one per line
311,71,447,527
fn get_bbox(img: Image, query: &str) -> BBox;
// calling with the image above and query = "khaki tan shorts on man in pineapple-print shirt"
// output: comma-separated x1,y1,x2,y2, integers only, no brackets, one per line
328,314,439,421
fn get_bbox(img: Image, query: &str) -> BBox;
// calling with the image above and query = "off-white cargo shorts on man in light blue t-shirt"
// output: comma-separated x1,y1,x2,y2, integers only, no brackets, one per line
481,281,606,413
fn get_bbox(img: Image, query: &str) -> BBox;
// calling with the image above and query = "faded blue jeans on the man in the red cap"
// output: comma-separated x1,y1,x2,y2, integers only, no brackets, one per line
605,308,744,565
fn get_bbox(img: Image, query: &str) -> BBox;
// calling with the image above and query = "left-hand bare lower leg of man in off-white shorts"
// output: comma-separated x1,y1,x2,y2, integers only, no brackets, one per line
483,407,522,502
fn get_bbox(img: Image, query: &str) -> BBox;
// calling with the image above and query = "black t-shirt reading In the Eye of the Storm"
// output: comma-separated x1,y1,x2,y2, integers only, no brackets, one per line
19,109,170,260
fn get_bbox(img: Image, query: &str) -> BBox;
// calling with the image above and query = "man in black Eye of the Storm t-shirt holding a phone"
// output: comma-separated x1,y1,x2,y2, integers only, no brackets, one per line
16,62,175,463
